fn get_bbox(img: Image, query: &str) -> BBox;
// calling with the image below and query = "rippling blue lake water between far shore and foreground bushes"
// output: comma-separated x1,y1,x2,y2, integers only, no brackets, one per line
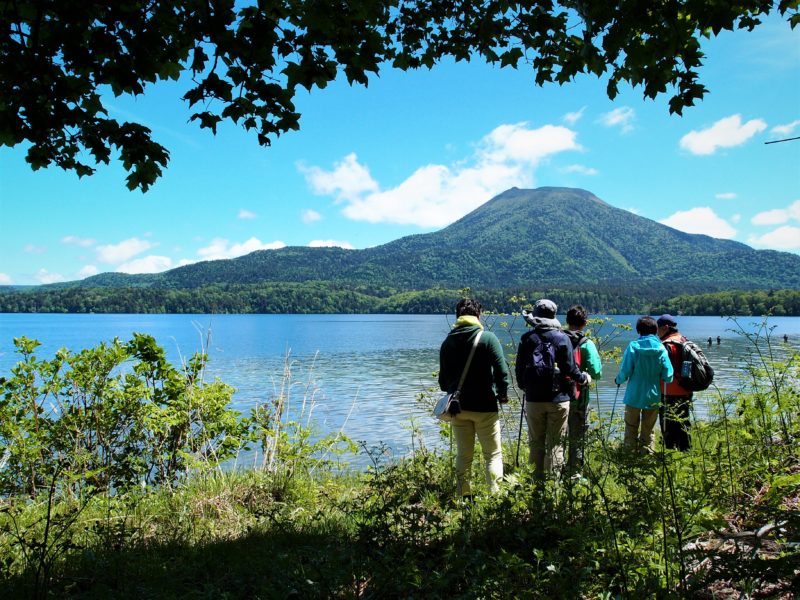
0,314,800,464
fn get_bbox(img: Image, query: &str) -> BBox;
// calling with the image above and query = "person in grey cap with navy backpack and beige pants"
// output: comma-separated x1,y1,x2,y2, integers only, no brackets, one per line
515,298,592,476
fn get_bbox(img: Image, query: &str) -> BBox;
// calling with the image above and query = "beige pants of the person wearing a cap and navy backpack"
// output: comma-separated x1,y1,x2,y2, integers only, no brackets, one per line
525,402,569,474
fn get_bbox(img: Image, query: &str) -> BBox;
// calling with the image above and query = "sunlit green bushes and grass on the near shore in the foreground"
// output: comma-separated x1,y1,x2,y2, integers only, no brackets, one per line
0,322,800,599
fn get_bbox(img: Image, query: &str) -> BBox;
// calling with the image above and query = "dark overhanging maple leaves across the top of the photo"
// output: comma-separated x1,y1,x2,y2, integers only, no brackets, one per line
0,0,800,191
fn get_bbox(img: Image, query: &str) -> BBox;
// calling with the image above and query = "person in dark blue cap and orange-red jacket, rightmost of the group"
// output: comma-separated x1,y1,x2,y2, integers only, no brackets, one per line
656,315,696,452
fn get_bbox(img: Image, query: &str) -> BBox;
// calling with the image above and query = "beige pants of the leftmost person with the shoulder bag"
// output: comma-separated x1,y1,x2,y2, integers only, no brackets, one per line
451,410,503,496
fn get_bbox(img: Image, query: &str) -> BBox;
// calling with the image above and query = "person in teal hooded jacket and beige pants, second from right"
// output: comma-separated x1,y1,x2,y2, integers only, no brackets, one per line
614,317,673,453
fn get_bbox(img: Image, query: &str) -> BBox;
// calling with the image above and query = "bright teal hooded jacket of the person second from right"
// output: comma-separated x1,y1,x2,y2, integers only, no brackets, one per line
614,335,672,409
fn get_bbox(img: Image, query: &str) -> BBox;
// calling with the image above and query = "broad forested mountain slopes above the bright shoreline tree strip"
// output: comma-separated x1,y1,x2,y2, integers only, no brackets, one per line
67,187,800,293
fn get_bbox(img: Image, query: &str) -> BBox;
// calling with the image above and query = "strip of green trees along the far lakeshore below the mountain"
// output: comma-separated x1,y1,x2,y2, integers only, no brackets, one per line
0,281,800,316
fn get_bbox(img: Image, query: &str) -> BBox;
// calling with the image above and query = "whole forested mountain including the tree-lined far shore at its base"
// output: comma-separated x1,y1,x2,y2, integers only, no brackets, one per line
0,188,800,315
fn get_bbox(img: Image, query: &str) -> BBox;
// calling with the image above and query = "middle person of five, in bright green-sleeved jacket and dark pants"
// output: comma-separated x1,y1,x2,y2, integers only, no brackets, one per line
565,304,603,474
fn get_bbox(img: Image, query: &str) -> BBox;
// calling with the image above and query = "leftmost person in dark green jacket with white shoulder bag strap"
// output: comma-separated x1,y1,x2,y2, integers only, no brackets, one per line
439,298,510,498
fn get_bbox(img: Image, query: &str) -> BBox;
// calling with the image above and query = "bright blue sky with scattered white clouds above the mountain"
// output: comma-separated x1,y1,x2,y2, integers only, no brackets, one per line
0,17,800,285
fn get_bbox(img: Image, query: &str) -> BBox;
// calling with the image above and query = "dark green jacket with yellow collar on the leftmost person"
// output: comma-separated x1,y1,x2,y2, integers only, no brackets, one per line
439,322,510,412
